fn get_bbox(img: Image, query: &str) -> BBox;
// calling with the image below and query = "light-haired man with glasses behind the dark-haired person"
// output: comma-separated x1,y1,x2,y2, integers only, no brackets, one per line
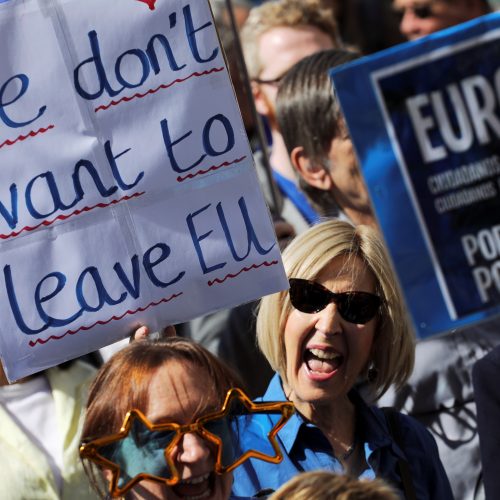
241,0,340,233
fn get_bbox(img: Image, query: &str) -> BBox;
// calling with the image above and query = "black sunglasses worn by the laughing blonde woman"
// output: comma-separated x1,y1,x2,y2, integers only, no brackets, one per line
288,278,382,325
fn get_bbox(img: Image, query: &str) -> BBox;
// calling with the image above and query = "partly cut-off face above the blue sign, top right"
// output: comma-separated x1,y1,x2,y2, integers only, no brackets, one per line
393,0,483,40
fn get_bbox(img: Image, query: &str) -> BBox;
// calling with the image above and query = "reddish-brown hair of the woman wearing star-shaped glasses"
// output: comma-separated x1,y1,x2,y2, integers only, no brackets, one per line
82,337,241,497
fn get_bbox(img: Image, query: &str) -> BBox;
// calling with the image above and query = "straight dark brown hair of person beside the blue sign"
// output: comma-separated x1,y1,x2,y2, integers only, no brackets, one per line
276,49,359,216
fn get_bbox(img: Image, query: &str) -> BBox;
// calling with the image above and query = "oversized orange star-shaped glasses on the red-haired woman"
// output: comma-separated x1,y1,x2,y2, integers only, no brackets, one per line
80,388,294,497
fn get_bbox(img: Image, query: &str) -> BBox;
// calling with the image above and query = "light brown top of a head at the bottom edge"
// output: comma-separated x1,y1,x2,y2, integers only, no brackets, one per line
269,471,399,500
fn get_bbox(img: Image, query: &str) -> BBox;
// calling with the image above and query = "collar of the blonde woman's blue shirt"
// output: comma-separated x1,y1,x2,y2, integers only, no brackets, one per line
262,374,406,459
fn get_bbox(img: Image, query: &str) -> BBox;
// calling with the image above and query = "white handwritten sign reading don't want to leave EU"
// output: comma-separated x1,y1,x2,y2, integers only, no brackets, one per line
0,0,287,380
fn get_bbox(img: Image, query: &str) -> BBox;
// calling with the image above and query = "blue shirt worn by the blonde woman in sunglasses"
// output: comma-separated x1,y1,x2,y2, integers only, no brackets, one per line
233,375,453,500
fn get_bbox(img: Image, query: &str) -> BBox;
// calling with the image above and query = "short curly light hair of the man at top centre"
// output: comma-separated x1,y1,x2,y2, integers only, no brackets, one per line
241,0,340,79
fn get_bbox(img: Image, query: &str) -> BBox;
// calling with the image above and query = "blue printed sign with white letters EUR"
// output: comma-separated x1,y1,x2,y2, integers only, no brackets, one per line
332,14,500,337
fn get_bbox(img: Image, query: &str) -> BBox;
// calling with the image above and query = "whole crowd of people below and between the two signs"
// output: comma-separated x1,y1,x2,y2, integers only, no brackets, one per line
0,0,500,500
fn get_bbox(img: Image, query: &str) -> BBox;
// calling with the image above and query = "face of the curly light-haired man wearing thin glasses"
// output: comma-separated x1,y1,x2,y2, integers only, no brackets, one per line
254,26,334,126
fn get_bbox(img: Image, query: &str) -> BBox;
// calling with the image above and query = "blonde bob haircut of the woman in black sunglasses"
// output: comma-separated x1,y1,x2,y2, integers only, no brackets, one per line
257,220,415,398
